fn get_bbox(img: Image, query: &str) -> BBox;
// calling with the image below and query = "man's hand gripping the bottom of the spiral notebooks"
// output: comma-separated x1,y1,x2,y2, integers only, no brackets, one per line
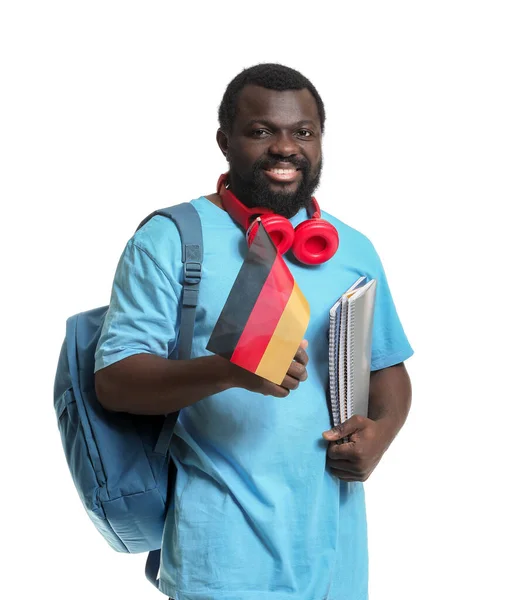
322,415,392,481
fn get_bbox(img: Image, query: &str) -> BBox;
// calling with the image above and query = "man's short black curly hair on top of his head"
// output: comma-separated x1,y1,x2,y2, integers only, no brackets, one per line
218,63,326,133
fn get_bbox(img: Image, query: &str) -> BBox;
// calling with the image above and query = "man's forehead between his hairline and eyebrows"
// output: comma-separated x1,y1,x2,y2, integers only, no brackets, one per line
235,85,320,127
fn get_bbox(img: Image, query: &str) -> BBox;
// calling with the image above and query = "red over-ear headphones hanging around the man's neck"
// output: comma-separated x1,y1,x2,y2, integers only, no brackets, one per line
217,173,339,265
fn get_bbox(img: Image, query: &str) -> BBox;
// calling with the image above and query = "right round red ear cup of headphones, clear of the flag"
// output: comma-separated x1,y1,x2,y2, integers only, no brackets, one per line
292,218,339,265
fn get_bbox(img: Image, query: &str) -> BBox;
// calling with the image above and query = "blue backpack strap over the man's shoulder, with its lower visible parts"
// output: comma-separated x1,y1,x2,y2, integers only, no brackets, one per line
138,202,203,589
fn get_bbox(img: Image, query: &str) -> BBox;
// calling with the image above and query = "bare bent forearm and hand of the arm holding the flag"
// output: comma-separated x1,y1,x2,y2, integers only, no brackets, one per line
95,341,308,415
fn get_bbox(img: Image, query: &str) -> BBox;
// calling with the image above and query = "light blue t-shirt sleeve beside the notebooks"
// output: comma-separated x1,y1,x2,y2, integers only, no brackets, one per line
371,240,414,371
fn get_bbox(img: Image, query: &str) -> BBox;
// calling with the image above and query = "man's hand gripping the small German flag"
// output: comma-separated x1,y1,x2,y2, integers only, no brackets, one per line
231,340,308,398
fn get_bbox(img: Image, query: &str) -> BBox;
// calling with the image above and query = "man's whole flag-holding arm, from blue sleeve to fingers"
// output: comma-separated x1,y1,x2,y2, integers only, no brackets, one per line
95,234,308,415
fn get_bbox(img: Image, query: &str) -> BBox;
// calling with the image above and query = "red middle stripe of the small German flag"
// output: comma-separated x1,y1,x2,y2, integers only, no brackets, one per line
230,254,294,372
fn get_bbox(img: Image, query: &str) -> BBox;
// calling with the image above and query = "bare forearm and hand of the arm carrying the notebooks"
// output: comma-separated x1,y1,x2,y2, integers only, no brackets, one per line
323,363,412,481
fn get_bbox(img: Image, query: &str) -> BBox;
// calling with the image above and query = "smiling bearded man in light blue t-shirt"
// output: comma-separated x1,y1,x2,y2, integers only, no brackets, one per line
96,64,412,600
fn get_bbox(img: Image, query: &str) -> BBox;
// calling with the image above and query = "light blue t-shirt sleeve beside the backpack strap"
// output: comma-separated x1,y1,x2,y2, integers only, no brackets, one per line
95,239,179,371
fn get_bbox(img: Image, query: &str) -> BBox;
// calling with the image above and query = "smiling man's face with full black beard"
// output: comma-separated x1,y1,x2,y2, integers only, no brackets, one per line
218,85,322,217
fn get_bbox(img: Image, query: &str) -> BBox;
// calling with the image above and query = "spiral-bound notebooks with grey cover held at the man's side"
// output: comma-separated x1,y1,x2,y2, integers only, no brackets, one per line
329,277,377,427
